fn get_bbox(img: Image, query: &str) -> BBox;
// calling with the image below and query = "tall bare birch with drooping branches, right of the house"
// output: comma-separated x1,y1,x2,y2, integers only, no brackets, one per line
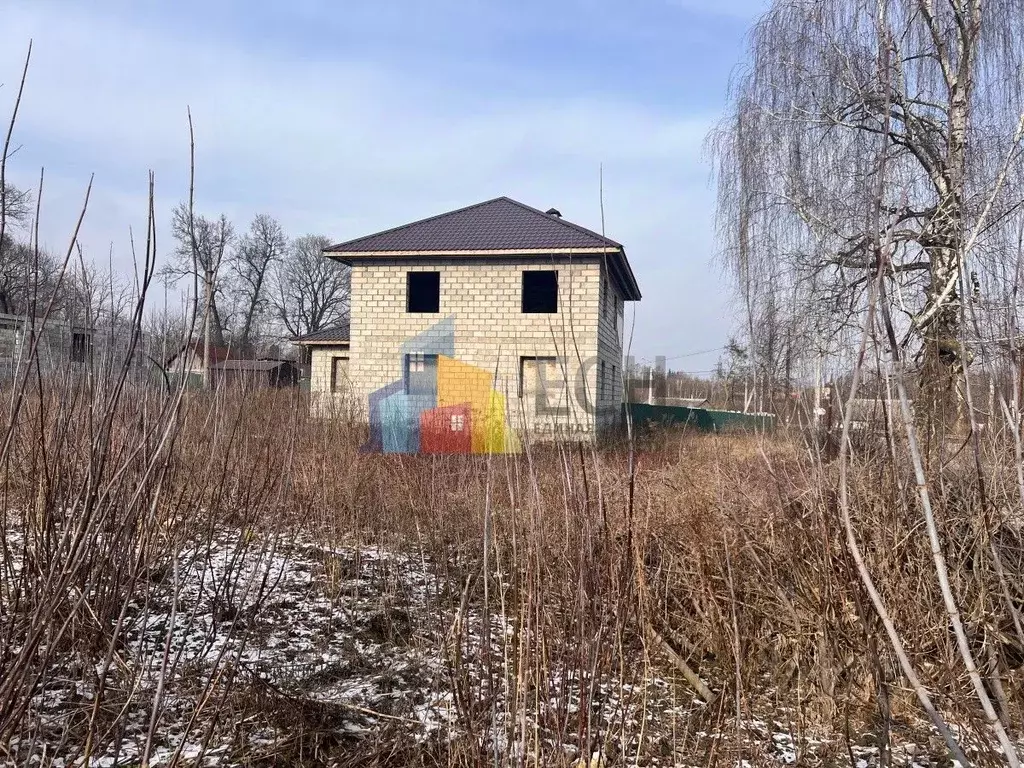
713,0,1024,423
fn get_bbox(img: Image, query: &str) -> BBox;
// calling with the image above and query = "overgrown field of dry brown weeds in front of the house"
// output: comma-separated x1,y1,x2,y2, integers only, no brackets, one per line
0,377,1024,766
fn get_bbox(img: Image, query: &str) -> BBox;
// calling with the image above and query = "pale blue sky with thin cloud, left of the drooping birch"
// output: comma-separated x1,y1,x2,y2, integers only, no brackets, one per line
0,0,765,371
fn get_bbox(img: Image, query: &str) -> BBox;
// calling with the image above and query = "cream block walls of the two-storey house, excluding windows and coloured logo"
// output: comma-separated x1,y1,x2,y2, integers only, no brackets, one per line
339,257,622,434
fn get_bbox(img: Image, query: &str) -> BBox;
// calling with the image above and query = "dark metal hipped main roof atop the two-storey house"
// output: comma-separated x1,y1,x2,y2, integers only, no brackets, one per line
325,198,640,300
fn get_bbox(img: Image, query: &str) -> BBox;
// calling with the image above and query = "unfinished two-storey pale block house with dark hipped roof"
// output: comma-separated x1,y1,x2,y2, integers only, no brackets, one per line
297,198,640,453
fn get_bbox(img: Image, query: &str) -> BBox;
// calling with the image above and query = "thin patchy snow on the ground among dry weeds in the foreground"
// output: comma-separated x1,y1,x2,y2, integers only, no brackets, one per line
0,530,1015,768
